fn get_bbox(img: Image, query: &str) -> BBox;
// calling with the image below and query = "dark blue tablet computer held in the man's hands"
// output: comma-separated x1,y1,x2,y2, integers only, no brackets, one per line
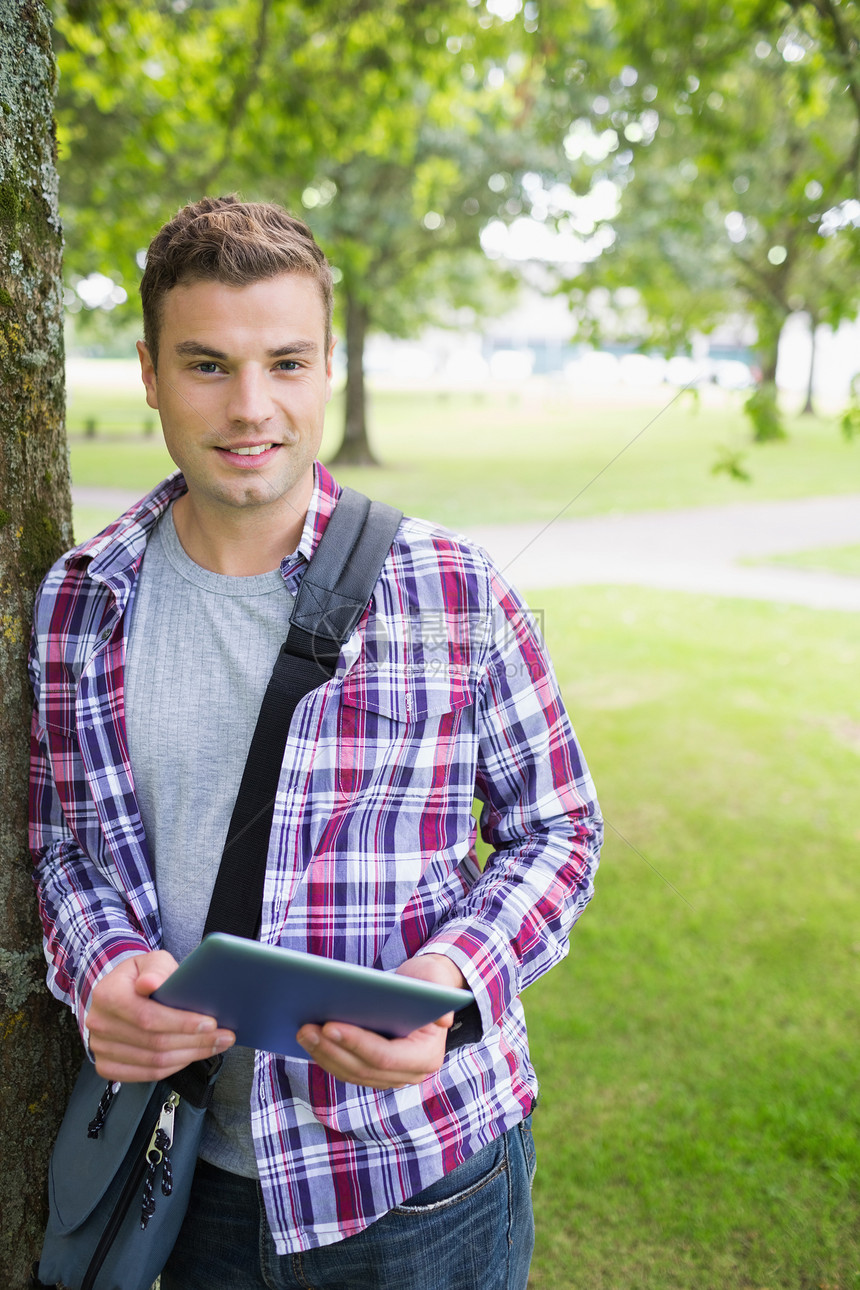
152,931,474,1062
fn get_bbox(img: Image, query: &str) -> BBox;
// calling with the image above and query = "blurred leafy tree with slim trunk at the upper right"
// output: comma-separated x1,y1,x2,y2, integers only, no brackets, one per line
544,0,860,441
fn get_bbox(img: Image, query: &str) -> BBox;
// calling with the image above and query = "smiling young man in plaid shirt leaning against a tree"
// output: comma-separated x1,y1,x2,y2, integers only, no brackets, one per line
32,197,601,1290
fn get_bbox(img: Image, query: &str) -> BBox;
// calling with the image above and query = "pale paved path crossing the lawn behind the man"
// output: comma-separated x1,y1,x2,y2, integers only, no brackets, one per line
73,488,860,613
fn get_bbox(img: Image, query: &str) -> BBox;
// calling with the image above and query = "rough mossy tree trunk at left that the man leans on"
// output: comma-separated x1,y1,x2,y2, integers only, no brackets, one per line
0,0,80,1290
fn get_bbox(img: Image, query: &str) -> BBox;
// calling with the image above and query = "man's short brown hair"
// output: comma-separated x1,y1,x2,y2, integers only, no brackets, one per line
141,195,333,366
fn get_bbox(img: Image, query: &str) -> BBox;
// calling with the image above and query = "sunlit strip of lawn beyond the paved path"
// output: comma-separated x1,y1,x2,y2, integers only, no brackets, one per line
70,387,860,535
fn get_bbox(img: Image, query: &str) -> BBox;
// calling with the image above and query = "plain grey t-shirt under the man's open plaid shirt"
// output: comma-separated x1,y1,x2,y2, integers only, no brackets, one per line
125,508,293,1178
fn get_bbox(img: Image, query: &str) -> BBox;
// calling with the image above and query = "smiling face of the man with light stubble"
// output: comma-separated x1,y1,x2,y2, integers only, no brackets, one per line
138,273,334,524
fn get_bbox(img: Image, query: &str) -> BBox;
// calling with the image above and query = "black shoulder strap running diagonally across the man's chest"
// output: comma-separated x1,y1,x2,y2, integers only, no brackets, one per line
204,488,402,938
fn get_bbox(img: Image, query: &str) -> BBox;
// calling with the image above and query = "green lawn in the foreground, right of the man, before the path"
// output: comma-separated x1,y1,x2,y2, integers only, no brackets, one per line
526,588,860,1290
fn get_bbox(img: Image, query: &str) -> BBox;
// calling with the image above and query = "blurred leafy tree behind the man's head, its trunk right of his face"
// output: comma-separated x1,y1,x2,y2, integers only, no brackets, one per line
55,0,564,464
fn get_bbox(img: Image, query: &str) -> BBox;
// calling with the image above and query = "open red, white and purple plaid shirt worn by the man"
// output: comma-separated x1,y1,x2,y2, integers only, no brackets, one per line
31,466,601,1253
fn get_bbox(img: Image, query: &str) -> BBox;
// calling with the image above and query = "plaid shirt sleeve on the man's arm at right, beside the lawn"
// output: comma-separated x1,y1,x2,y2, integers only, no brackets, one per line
420,571,602,1032
